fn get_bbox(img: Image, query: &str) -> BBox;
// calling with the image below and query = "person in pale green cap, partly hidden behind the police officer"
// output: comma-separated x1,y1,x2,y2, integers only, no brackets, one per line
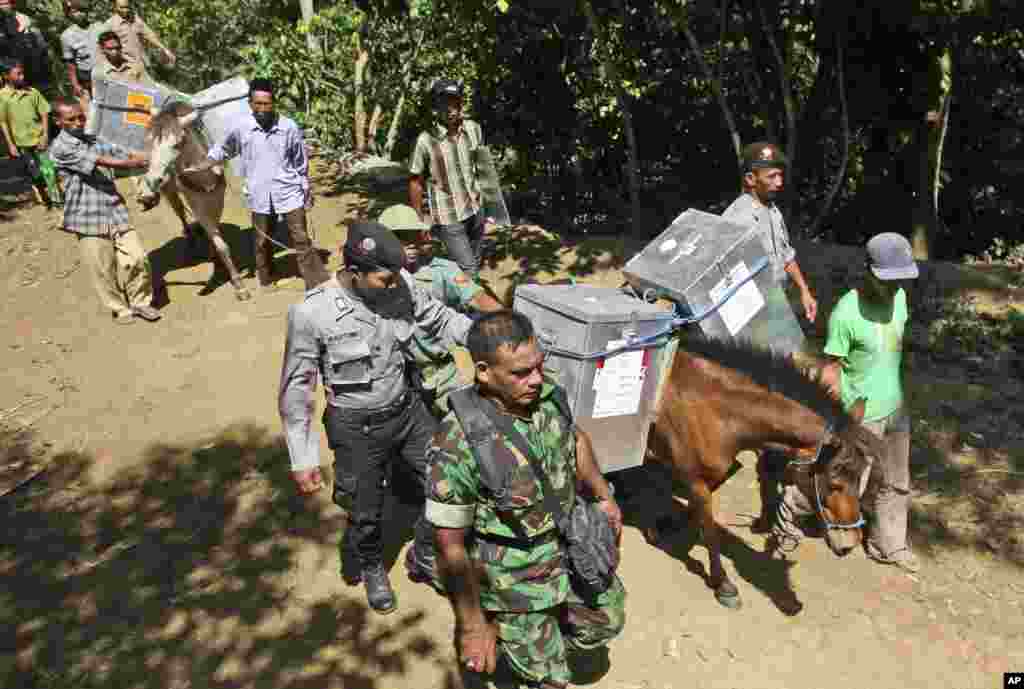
377,204,504,419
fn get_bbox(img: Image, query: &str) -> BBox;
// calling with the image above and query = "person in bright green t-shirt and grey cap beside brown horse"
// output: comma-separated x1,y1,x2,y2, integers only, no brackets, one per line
824,232,921,571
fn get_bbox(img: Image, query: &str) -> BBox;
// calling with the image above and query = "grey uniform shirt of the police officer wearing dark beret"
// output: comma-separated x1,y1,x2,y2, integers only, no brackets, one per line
278,270,472,471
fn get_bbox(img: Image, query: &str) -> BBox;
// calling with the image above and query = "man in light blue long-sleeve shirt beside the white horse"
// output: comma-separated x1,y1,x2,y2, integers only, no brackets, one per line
199,79,330,290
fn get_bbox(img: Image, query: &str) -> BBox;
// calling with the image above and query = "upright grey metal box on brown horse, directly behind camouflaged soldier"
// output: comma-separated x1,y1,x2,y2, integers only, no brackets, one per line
513,285,676,473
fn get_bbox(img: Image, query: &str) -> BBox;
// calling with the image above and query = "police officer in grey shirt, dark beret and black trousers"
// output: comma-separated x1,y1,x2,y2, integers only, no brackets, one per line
279,222,471,613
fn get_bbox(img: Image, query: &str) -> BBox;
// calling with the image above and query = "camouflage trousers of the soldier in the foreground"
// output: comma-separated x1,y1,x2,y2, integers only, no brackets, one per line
494,576,626,687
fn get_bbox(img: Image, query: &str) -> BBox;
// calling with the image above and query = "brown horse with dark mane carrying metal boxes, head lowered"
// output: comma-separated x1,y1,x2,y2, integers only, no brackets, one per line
648,337,884,608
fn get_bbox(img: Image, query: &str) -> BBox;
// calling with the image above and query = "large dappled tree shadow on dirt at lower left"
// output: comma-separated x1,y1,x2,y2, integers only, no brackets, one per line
0,425,456,689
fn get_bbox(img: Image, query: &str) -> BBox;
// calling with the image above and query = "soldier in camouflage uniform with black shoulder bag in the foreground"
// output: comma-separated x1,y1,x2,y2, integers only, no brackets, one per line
426,310,626,687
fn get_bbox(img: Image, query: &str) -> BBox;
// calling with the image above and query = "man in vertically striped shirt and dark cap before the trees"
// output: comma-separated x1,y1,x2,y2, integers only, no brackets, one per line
409,79,484,278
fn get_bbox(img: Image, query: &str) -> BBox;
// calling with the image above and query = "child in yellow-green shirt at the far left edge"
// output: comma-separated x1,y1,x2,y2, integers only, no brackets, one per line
0,62,60,208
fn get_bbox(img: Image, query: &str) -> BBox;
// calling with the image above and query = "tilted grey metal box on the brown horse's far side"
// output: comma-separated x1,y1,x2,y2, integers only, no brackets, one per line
623,209,804,354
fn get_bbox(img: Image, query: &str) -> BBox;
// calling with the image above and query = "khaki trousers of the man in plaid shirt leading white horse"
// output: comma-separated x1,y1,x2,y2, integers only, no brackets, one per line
78,229,153,313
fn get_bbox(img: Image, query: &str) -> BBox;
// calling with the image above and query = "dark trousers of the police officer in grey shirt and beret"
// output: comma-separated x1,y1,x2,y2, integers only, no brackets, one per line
324,390,436,568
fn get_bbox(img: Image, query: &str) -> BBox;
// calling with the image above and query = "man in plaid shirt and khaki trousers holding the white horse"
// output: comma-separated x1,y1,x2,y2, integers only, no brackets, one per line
50,102,160,324
